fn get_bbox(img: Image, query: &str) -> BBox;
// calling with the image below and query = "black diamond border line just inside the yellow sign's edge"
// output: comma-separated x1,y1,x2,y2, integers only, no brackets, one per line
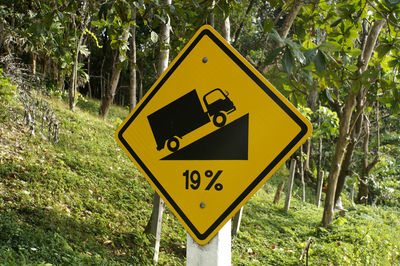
118,26,308,240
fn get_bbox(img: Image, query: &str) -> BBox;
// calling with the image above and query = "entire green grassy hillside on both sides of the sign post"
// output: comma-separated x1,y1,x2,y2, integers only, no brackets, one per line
0,95,400,265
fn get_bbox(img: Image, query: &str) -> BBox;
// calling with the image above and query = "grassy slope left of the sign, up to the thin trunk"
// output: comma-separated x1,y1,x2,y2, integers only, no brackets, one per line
0,99,155,264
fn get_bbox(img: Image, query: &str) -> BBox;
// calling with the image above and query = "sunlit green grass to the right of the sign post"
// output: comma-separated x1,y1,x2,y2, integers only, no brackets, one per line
233,175,400,265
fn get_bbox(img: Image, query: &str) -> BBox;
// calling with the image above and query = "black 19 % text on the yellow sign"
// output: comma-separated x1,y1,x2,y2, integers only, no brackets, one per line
183,170,224,191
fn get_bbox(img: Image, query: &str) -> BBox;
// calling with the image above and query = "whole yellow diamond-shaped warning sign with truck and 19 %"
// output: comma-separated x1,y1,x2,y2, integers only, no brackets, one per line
116,25,312,245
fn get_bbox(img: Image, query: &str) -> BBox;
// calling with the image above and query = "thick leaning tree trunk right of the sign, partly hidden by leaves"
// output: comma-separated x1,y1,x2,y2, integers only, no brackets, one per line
322,20,385,226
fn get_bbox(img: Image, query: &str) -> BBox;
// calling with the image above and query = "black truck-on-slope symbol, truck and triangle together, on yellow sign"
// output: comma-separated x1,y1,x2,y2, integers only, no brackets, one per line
147,88,249,160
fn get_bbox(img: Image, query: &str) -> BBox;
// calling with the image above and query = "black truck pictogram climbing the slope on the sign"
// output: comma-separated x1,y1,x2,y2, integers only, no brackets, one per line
147,88,236,152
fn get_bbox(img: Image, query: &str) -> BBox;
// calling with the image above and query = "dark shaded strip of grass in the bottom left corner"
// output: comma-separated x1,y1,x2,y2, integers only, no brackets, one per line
0,202,152,265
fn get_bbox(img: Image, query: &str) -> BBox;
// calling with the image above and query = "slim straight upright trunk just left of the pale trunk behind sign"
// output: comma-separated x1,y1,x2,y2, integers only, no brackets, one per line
129,5,137,111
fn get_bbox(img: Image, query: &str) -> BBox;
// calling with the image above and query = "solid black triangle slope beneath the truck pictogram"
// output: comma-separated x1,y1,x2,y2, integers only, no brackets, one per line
161,114,249,160
